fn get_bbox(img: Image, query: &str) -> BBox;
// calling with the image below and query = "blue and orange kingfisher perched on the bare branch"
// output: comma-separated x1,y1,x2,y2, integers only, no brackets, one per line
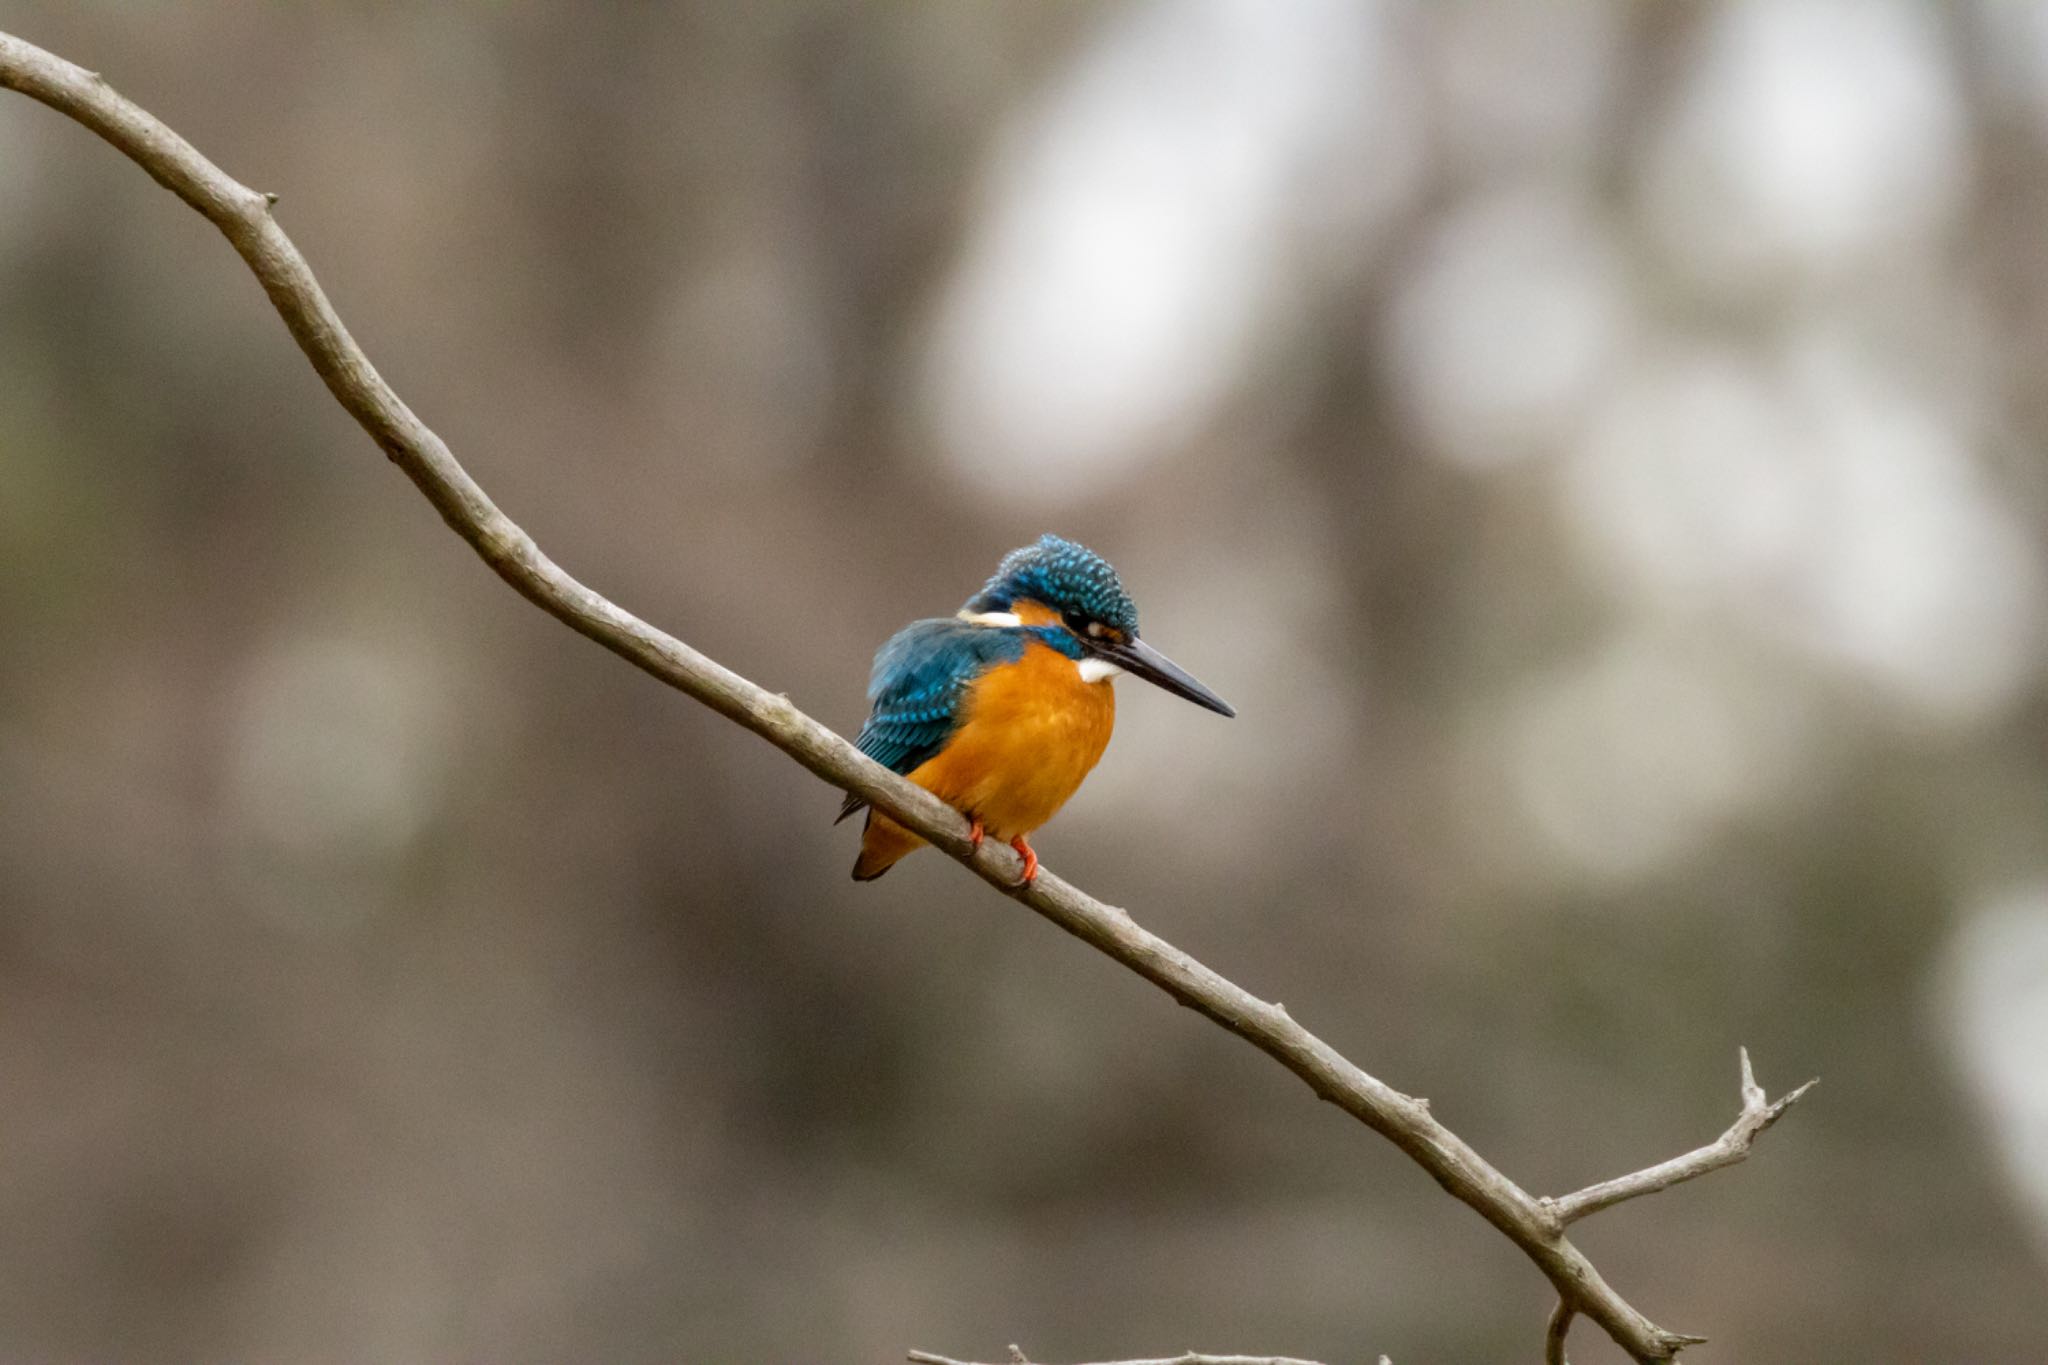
836,534,1237,886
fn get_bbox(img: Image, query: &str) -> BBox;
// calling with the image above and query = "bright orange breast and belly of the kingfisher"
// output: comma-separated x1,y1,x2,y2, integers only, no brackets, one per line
909,641,1116,839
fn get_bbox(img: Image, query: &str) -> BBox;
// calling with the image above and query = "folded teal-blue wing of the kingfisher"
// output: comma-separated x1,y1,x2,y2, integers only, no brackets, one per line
840,620,1026,821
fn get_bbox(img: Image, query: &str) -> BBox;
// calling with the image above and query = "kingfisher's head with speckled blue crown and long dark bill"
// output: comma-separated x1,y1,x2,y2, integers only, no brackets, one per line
961,534,1237,716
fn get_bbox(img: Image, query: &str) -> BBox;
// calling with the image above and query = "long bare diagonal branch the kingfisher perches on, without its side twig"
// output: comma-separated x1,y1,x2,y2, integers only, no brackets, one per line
0,33,1810,1361
